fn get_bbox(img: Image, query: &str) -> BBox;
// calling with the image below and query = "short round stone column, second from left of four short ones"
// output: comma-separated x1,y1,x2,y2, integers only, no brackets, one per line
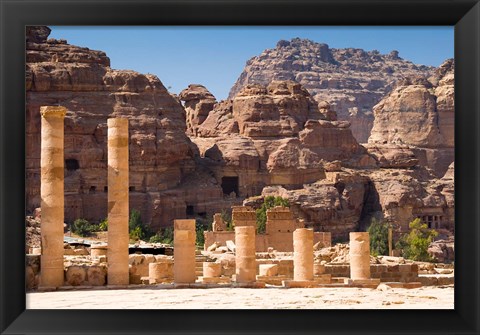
235,226,257,283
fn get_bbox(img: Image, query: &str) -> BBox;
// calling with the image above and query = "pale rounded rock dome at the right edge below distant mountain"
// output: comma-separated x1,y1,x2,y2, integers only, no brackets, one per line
368,60,455,177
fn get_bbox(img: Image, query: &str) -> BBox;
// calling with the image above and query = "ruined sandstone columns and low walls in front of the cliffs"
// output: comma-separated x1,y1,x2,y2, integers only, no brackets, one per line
26,106,450,290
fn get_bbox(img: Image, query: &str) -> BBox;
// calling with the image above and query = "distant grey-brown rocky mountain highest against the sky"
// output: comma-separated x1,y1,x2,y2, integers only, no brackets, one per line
229,38,435,143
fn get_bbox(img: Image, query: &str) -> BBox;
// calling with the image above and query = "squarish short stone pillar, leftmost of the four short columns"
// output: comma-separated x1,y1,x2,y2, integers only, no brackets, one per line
173,220,197,284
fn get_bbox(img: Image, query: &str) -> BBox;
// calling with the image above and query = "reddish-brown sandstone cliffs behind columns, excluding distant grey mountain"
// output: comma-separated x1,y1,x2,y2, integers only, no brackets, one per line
26,27,454,242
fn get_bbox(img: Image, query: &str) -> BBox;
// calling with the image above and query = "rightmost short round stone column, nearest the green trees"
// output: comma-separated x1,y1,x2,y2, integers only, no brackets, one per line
350,232,370,280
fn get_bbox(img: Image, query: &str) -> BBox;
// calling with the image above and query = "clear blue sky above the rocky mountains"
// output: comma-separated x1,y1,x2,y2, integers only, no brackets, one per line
50,26,454,100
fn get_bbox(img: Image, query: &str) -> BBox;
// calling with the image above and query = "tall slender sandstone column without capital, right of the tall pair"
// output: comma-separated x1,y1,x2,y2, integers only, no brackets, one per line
107,118,129,285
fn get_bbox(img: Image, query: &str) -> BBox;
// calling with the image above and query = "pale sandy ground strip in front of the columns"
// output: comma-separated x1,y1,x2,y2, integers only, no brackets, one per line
27,285,454,309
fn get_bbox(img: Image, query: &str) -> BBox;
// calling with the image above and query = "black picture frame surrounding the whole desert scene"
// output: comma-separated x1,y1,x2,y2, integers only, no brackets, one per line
0,0,480,334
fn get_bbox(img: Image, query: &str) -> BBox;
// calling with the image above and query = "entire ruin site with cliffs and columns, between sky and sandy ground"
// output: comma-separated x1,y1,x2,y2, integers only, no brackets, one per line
25,26,455,308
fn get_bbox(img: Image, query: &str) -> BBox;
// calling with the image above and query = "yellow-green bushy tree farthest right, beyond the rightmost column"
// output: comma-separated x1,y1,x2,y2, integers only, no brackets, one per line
396,219,438,262
